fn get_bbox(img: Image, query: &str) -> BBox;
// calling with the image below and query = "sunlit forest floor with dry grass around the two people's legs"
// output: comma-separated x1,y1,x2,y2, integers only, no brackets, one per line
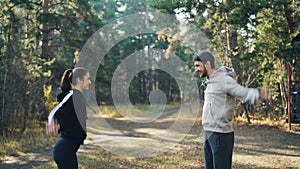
0,111,300,169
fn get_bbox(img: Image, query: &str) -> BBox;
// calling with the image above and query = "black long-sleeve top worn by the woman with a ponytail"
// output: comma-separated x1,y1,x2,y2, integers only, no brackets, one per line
54,89,87,144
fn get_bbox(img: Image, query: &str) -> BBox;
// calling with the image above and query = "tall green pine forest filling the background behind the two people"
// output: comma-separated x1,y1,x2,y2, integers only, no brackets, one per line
0,0,300,136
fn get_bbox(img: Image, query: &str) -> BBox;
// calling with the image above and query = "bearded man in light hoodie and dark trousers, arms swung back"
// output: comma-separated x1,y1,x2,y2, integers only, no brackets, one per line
194,51,270,169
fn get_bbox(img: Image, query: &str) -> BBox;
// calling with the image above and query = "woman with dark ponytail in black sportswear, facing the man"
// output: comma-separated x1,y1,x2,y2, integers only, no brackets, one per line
53,67,91,169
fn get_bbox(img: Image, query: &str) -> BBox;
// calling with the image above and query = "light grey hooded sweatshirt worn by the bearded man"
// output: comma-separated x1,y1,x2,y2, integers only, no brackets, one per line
202,67,259,133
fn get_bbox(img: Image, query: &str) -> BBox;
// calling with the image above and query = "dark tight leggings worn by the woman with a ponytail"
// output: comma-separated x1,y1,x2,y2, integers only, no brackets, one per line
53,137,80,169
